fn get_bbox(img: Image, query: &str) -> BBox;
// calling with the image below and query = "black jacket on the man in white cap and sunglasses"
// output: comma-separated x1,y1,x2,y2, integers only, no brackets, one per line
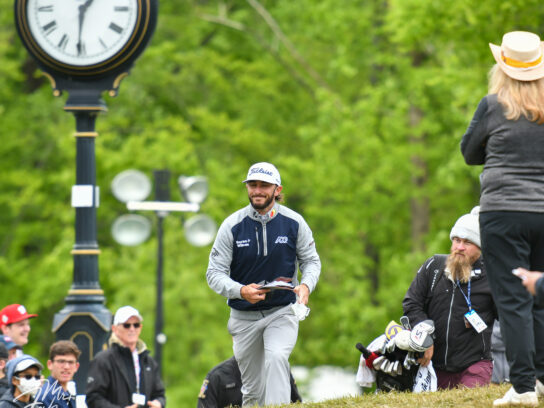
87,335,166,408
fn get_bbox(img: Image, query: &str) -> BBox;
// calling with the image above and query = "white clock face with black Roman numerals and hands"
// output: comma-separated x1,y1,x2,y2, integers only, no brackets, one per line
26,0,140,67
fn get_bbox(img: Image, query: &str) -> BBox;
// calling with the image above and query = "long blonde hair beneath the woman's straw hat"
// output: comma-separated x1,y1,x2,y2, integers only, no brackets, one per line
489,64,544,124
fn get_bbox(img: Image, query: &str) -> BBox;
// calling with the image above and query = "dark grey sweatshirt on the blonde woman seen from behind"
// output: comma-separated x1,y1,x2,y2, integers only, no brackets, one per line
461,94,544,213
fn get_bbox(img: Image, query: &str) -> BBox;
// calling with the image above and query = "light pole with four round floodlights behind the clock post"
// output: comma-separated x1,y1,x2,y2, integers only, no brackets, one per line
111,170,216,370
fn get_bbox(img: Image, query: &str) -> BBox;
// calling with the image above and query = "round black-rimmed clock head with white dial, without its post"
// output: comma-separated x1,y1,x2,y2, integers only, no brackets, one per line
15,0,157,89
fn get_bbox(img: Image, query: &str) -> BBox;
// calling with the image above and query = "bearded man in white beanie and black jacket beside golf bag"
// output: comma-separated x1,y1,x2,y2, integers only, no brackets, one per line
402,207,497,389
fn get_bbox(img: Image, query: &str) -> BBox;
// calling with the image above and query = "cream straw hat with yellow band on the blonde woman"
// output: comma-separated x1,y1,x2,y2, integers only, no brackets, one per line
489,31,544,81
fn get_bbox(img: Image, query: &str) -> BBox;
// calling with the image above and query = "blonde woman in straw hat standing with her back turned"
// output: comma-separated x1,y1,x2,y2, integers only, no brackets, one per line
461,31,544,406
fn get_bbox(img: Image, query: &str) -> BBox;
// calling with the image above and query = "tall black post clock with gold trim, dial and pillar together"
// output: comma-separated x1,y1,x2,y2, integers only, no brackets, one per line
15,0,158,394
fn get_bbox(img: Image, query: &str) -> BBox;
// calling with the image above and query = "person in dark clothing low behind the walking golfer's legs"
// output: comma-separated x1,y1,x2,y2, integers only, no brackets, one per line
196,357,302,408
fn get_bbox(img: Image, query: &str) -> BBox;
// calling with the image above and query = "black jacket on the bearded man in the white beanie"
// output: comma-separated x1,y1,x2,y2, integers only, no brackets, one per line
402,255,497,373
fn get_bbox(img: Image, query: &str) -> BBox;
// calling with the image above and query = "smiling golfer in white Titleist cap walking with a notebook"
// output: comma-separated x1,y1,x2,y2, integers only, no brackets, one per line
206,163,321,406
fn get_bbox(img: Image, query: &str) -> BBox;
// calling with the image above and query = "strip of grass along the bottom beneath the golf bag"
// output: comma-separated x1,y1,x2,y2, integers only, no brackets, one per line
269,384,520,408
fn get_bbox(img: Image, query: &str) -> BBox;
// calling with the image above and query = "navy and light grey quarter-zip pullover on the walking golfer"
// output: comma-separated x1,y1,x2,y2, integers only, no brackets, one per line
206,203,321,311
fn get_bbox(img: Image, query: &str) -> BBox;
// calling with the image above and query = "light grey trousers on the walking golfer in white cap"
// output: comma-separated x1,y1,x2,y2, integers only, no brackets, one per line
228,305,299,406
